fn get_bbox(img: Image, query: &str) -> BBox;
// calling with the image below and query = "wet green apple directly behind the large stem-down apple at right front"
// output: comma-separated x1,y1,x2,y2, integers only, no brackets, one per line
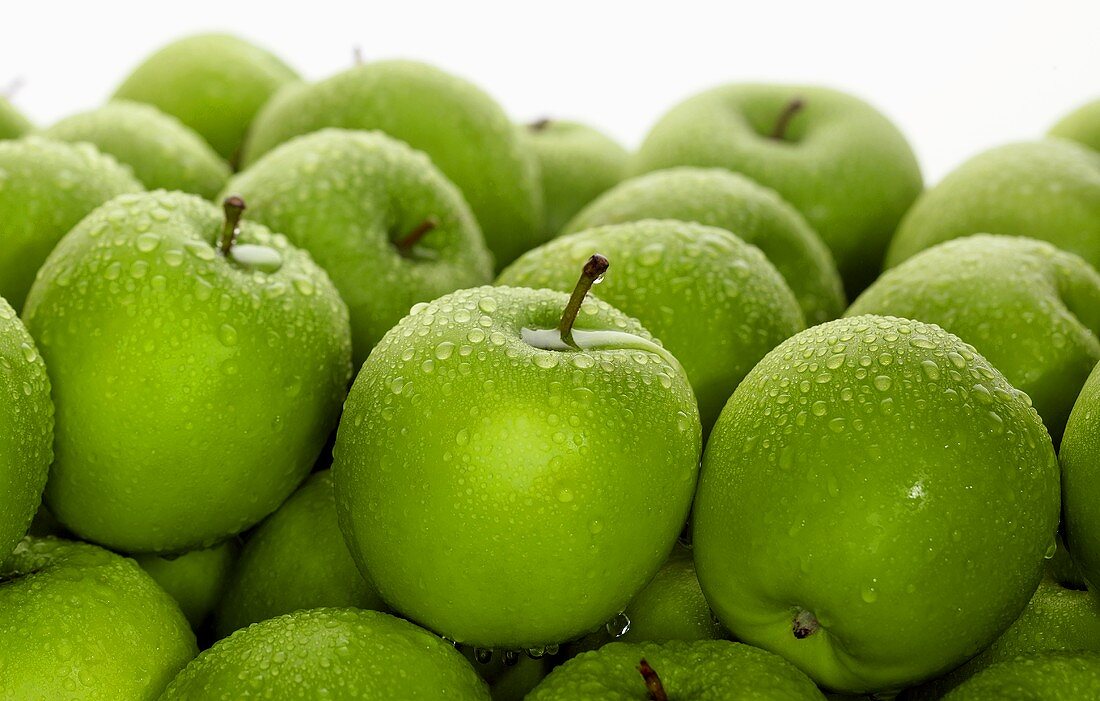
847,234,1100,442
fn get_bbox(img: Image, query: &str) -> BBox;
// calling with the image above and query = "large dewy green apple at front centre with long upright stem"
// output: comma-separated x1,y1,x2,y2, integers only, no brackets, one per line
332,264,700,649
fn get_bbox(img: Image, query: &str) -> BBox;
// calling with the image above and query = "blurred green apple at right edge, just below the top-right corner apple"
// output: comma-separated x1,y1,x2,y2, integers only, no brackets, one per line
887,139,1100,267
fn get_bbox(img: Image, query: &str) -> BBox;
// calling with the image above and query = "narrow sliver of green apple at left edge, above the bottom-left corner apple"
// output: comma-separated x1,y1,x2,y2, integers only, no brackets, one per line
0,297,54,559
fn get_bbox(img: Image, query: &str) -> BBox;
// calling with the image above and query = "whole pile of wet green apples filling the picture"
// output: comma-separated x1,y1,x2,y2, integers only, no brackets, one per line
0,34,1100,701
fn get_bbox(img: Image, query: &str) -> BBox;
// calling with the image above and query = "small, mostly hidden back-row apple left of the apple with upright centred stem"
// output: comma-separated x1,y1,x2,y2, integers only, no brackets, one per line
520,119,627,239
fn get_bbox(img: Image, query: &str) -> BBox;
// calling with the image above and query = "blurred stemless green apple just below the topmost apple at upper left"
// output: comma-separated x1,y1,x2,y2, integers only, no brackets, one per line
42,100,230,199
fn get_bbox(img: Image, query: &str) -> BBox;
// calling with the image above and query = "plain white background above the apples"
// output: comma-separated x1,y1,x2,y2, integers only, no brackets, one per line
0,0,1100,183
